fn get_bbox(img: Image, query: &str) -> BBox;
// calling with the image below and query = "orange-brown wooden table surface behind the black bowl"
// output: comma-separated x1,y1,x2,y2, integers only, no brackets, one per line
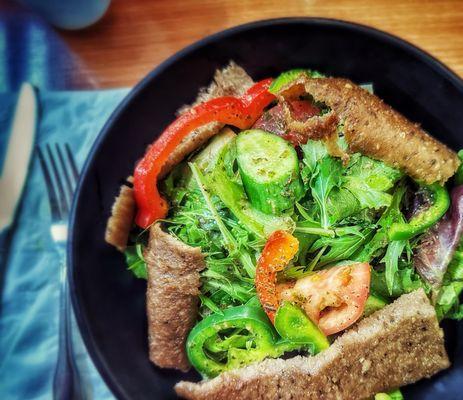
59,0,463,87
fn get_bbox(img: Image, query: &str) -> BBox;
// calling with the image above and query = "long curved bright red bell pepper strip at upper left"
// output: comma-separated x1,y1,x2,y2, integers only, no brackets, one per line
133,78,275,229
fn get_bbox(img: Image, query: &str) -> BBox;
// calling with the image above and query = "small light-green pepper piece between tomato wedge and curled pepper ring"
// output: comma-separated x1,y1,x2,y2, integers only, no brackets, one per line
275,301,330,354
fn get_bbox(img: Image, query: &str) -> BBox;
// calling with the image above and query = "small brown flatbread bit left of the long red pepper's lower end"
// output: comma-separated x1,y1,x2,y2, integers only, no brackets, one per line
105,178,135,251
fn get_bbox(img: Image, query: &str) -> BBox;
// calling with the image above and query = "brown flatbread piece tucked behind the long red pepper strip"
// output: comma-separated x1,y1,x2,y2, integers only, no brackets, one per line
160,62,253,178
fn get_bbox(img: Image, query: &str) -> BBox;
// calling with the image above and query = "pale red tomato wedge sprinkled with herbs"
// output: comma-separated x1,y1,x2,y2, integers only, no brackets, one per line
281,263,370,335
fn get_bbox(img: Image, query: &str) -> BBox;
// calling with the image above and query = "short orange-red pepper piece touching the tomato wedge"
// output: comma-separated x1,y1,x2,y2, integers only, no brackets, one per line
255,231,299,323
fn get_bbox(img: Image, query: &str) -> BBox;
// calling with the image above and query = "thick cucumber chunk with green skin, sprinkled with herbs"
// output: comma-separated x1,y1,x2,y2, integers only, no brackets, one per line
237,130,304,215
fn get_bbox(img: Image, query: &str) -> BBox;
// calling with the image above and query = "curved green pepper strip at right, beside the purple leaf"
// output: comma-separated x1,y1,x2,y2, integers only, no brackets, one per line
388,183,450,240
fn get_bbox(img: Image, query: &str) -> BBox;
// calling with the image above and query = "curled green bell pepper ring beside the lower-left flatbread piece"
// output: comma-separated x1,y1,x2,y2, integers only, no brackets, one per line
186,305,304,378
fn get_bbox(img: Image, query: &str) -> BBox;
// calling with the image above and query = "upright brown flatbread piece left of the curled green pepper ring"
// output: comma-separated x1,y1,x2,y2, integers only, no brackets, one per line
145,224,205,371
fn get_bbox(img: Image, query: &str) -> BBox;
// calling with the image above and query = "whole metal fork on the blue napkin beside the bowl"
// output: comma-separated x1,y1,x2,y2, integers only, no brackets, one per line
37,143,84,400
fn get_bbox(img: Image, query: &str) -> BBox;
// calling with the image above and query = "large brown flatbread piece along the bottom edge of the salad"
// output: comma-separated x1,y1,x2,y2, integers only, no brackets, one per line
175,289,449,400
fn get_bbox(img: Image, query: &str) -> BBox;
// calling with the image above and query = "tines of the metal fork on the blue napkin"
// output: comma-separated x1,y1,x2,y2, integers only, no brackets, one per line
37,143,79,220
